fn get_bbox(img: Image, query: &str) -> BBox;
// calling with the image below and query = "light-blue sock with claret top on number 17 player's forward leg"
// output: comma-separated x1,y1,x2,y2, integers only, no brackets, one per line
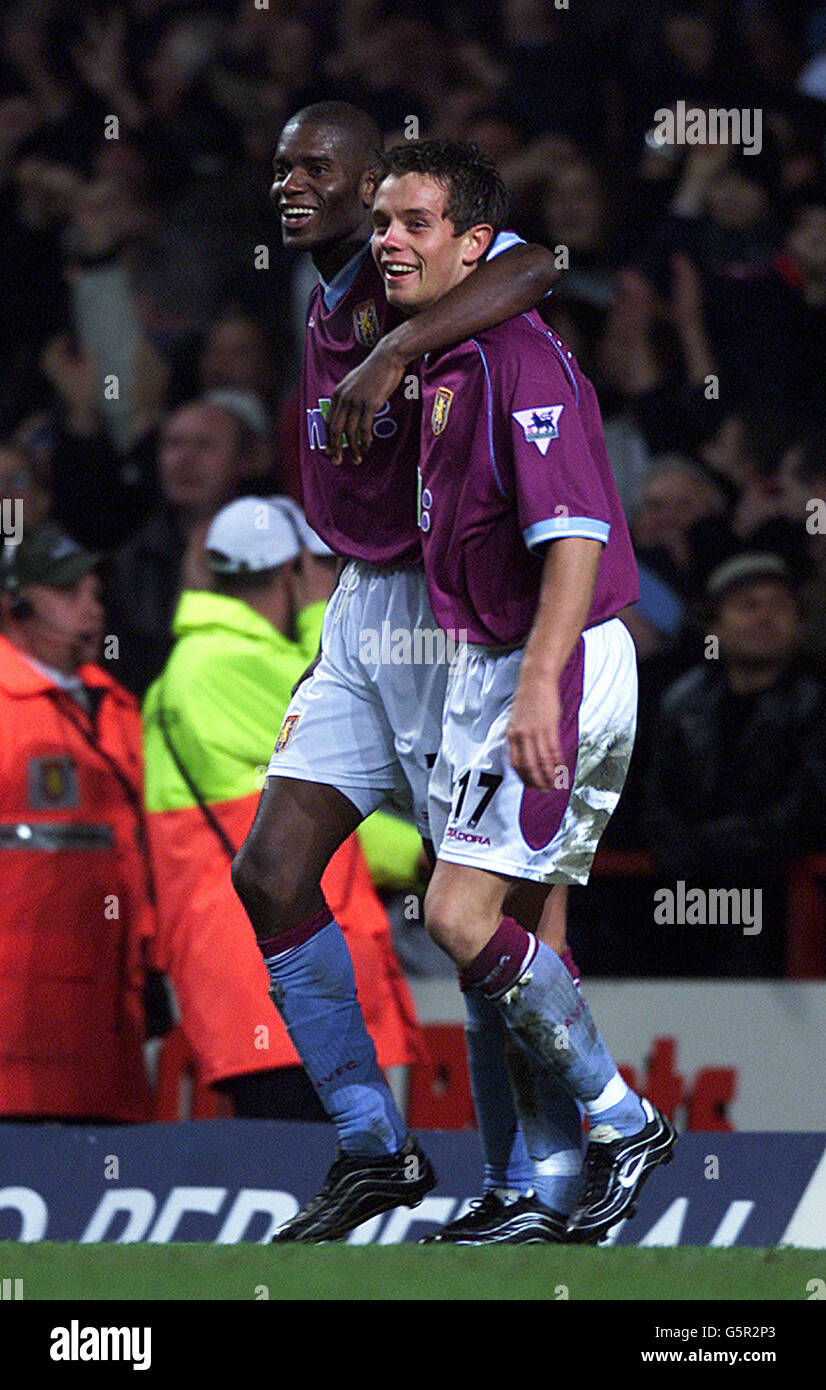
462,917,647,1137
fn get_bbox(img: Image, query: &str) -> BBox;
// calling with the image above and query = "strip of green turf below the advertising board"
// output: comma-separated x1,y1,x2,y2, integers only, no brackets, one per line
0,1241,826,1300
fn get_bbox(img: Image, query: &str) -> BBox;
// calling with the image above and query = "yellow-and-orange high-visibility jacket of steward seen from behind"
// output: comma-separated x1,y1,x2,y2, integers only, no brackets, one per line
143,591,421,1083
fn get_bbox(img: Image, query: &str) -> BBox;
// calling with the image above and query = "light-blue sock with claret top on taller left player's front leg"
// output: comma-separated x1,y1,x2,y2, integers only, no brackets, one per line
259,913,407,1155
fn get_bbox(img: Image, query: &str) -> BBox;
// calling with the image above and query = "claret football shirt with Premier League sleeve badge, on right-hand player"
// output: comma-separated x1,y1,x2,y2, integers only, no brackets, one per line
419,313,638,646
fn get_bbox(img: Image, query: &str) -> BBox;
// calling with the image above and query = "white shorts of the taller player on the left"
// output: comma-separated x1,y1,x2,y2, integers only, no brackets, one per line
267,560,455,837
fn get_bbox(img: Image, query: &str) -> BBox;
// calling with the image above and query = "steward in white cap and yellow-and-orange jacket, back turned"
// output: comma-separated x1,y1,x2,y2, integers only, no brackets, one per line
143,498,417,1119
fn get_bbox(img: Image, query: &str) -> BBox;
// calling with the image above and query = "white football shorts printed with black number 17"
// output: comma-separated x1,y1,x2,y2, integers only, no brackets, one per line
430,619,637,883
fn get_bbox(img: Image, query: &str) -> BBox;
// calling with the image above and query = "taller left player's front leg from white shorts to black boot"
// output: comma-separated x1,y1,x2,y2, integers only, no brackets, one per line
232,569,435,1240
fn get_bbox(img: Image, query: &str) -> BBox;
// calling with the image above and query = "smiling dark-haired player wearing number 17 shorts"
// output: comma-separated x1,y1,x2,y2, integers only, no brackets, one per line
373,140,676,1241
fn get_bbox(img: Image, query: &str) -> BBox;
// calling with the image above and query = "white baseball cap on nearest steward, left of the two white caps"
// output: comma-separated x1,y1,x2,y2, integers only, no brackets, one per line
204,498,300,574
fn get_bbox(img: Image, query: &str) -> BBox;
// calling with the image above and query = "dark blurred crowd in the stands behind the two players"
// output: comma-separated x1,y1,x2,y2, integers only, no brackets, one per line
0,0,826,1084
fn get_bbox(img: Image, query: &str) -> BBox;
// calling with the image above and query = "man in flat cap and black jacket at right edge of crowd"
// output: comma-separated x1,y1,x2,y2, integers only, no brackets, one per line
647,553,826,976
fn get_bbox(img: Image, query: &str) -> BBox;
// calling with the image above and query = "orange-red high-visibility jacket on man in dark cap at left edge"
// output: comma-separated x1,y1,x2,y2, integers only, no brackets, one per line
0,637,154,1120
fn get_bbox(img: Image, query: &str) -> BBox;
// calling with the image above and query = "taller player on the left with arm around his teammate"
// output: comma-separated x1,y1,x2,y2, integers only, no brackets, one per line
234,101,570,1241
